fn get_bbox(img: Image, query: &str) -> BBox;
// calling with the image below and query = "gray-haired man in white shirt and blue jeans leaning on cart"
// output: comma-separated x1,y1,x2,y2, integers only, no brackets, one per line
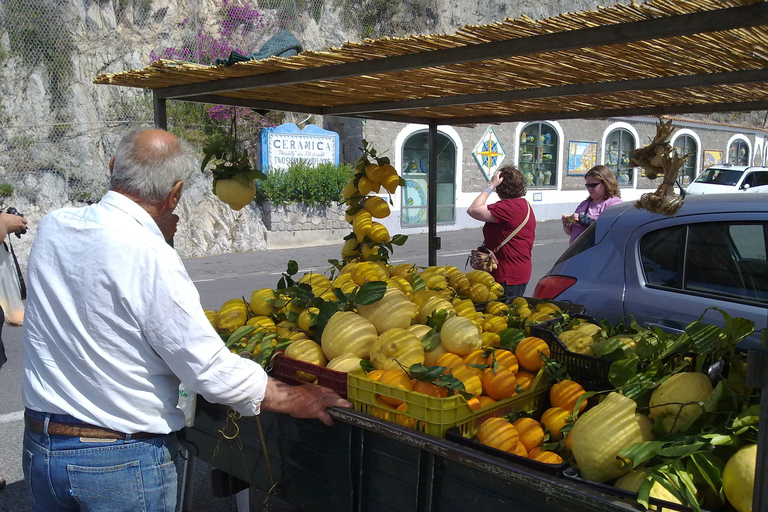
23,129,352,512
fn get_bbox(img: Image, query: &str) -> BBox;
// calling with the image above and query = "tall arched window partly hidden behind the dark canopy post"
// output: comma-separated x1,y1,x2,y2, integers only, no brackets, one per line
402,130,456,226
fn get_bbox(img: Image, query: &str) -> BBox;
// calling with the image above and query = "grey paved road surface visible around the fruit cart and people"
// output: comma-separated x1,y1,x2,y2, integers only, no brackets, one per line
0,220,568,512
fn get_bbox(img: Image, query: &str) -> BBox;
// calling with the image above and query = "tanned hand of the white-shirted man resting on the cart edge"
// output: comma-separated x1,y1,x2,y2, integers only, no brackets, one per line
261,377,352,425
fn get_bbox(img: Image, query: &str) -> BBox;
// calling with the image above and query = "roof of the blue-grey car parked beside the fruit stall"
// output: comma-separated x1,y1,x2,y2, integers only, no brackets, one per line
595,194,768,241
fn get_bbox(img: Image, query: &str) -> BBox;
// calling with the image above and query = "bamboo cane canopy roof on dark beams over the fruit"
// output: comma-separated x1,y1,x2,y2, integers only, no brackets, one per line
94,0,768,125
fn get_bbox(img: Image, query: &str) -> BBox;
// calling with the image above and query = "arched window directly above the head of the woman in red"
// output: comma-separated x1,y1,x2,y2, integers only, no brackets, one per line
517,123,559,188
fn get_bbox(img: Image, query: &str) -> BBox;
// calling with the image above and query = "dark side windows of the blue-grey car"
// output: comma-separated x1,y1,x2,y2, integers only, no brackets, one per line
640,222,768,303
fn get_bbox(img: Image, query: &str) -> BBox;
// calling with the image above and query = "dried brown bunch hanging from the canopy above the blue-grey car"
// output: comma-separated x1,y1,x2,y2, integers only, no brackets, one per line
631,119,690,215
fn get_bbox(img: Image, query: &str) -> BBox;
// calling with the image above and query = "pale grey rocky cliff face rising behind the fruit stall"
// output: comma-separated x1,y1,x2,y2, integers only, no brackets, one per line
0,0,756,264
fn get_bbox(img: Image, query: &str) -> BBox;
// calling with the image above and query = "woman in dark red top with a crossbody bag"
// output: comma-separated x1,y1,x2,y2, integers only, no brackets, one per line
467,165,536,298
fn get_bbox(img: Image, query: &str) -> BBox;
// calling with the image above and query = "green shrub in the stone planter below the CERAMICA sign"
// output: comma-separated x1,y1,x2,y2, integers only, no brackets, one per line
256,160,354,206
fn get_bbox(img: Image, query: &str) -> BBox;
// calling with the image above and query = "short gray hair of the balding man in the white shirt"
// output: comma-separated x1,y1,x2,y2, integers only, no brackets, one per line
109,130,199,203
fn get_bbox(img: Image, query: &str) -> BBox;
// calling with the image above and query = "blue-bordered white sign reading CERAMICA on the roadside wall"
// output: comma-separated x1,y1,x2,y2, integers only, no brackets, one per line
262,124,339,171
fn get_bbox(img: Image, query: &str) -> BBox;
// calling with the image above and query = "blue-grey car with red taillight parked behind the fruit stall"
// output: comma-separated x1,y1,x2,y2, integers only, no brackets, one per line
533,194,768,348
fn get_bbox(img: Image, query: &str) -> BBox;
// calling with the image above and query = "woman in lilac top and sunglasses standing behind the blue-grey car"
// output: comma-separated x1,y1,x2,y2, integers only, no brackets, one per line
562,165,622,244
